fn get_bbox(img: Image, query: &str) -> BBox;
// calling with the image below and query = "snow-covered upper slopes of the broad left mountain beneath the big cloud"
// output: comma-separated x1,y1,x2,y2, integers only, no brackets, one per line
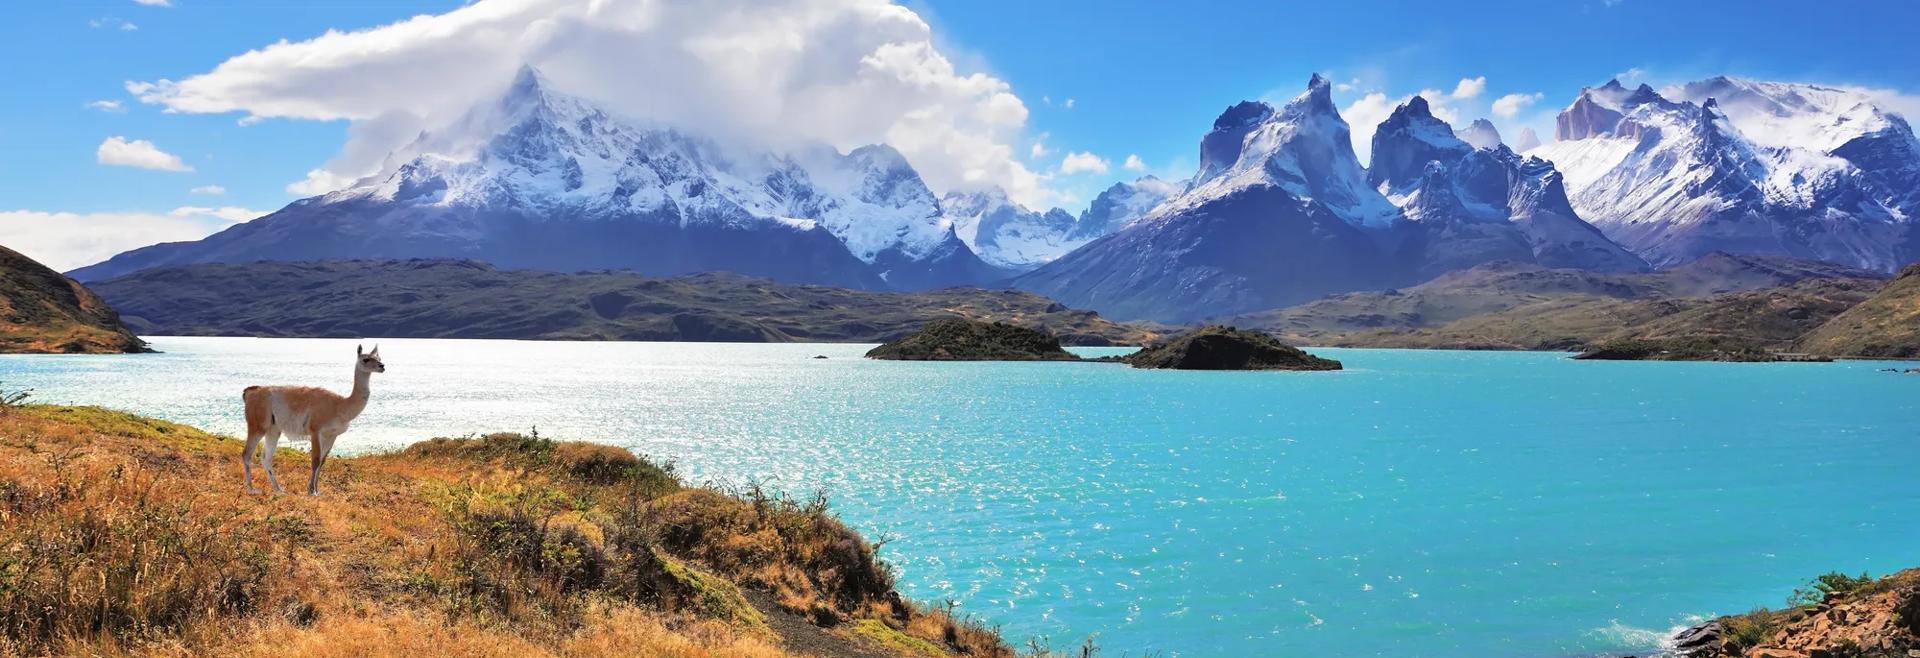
323,67,975,263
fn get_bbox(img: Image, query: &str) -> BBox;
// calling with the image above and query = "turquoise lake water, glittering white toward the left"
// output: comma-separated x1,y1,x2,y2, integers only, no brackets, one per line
0,338,1920,656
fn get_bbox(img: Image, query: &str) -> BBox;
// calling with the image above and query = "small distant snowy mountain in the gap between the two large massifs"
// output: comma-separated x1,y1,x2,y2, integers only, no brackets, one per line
941,188,1091,274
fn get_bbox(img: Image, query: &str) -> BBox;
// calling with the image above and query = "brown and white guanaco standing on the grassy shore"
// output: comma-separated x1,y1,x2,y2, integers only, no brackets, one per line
240,345,386,495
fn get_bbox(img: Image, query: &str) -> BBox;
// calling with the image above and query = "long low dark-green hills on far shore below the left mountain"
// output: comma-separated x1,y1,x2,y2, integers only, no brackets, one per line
94,261,1154,345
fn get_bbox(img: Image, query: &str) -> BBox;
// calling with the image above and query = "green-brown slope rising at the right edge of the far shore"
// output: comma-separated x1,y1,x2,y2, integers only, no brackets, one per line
1799,263,1920,359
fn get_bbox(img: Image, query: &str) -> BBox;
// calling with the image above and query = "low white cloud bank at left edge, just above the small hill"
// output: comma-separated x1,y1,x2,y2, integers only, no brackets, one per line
0,207,265,270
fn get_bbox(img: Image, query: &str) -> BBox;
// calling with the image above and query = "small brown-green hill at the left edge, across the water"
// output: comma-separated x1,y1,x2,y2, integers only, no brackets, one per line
0,247,148,353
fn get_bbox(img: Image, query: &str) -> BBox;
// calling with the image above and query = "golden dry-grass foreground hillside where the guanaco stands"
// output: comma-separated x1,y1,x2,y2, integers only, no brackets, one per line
0,407,1052,658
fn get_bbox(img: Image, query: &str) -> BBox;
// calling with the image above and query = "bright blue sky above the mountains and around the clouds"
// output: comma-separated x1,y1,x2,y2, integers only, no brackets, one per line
0,0,1920,265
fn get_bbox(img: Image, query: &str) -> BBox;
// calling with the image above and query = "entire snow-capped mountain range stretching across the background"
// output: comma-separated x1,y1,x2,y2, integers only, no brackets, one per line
60,67,1920,322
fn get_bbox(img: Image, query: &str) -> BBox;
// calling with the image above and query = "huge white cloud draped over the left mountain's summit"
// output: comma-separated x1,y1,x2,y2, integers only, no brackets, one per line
127,0,1052,205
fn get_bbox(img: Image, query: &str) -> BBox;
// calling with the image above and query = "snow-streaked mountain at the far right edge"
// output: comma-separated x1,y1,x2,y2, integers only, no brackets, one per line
1528,77,1920,270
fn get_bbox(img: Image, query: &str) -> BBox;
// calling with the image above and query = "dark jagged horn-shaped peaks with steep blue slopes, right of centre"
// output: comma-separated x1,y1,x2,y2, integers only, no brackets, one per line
1014,75,1645,320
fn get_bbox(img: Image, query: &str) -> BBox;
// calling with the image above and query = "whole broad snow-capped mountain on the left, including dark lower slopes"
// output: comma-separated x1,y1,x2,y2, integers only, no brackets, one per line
75,67,1000,288
